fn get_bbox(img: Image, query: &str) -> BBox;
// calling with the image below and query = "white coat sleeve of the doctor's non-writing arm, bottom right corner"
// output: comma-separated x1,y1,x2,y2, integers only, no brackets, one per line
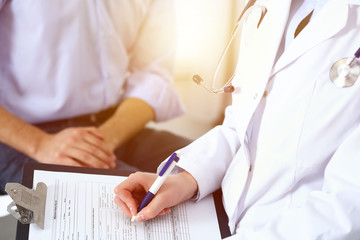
227,123,360,240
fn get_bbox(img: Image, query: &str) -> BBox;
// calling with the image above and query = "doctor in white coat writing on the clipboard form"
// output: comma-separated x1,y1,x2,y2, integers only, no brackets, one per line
115,0,360,240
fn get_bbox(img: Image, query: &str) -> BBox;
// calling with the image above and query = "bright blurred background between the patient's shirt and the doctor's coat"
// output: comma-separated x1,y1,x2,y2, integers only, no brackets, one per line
149,0,244,139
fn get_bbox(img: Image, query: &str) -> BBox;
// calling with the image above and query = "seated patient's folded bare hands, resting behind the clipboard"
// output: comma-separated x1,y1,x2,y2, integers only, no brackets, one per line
35,127,116,168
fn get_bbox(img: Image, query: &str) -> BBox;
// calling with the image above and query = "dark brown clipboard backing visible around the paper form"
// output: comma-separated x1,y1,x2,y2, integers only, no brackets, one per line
16,163,231,240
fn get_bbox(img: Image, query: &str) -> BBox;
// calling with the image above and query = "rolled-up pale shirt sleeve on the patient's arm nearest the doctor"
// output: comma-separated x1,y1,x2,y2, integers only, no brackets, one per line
125,0,184,121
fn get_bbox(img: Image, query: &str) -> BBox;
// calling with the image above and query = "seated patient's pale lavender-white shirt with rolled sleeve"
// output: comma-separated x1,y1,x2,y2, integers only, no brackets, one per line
0,0,184,123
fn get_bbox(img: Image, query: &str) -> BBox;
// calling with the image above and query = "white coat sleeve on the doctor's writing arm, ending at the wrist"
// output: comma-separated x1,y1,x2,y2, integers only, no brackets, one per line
178,106,240,200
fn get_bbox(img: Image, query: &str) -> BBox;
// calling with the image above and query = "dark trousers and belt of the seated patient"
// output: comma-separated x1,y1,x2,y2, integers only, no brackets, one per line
0,111,191,194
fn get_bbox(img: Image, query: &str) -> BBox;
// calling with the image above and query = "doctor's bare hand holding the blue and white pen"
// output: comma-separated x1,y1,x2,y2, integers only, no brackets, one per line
114,172,198,222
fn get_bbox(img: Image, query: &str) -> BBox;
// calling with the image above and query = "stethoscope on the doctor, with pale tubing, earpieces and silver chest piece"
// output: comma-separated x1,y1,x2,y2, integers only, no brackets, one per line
193,0,360,93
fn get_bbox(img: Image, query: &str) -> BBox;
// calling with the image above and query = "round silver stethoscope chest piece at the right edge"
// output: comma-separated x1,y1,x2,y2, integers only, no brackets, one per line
330,54,360,88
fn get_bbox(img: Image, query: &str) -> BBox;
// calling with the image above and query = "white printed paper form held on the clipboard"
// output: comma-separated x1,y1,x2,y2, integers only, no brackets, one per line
29,170,221,240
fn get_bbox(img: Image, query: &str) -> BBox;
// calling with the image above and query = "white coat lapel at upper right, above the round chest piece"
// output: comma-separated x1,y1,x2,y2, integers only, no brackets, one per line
273,0,348,74
